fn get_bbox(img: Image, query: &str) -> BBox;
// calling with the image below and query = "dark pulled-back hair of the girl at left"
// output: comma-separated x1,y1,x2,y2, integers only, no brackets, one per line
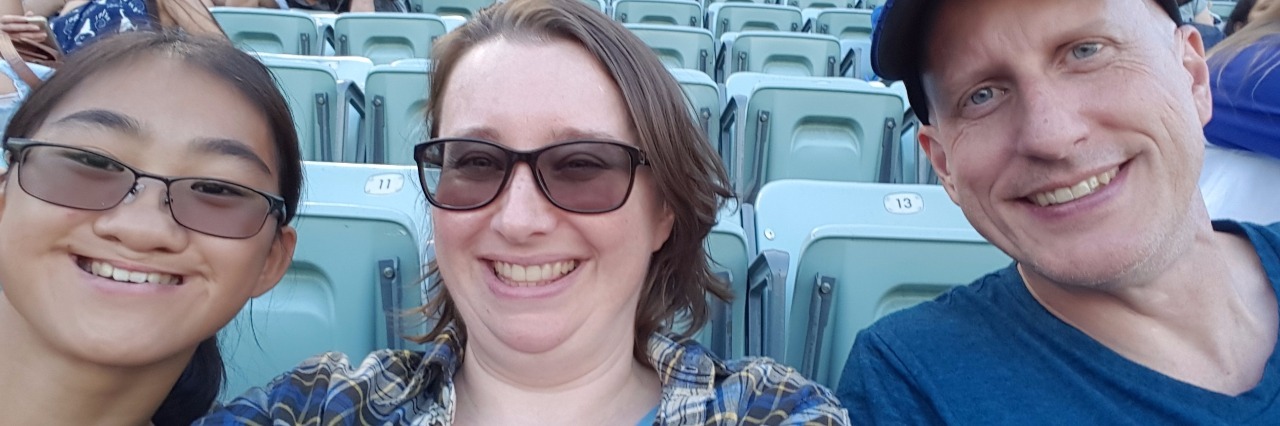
4,31,302,426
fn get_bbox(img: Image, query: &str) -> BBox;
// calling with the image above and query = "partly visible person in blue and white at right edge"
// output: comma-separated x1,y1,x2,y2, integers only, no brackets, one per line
1199,1,1280,223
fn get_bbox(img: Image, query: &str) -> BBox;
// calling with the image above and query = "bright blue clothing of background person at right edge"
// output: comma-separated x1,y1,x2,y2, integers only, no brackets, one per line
1204,35,1280,159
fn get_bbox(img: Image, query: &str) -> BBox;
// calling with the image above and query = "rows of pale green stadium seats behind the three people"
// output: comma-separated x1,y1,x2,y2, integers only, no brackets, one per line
214,0,1010,397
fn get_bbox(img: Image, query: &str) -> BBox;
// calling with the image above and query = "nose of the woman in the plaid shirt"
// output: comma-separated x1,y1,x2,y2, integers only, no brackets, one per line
490,164,557,243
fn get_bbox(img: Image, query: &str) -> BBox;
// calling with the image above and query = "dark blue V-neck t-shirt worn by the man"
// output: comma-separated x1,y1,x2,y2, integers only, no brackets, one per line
836,221,1280,425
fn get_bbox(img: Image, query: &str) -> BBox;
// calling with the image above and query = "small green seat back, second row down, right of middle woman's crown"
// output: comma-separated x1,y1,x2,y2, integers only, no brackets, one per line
626,24,716,75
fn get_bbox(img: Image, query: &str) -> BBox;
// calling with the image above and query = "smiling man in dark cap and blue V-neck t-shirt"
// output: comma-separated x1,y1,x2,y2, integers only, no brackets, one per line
838,0,1280,425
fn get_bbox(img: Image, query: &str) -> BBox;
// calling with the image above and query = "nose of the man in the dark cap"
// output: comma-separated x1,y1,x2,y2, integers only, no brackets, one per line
1018,79,1088,161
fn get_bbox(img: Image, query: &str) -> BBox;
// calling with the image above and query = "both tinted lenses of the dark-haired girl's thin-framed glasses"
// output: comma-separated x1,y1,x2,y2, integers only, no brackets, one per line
18,146,271,238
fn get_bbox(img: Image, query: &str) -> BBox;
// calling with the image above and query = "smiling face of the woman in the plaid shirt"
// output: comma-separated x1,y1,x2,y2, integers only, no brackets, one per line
431,38,673,358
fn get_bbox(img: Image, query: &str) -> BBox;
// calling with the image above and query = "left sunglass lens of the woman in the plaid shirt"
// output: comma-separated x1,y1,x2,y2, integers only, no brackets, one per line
421,141,509,209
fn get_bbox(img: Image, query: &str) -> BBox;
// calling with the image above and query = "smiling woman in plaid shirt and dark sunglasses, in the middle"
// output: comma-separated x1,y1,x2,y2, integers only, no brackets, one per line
204,0,847,425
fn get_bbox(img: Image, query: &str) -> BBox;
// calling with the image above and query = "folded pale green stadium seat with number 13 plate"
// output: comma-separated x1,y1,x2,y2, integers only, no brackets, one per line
744,179,1009,360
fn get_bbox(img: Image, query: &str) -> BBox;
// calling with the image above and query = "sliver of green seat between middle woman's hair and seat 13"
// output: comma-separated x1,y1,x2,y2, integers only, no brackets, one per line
695,201,750,358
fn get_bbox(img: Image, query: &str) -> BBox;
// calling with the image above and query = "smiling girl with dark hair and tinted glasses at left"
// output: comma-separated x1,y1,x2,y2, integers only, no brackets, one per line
0,32,301,425
